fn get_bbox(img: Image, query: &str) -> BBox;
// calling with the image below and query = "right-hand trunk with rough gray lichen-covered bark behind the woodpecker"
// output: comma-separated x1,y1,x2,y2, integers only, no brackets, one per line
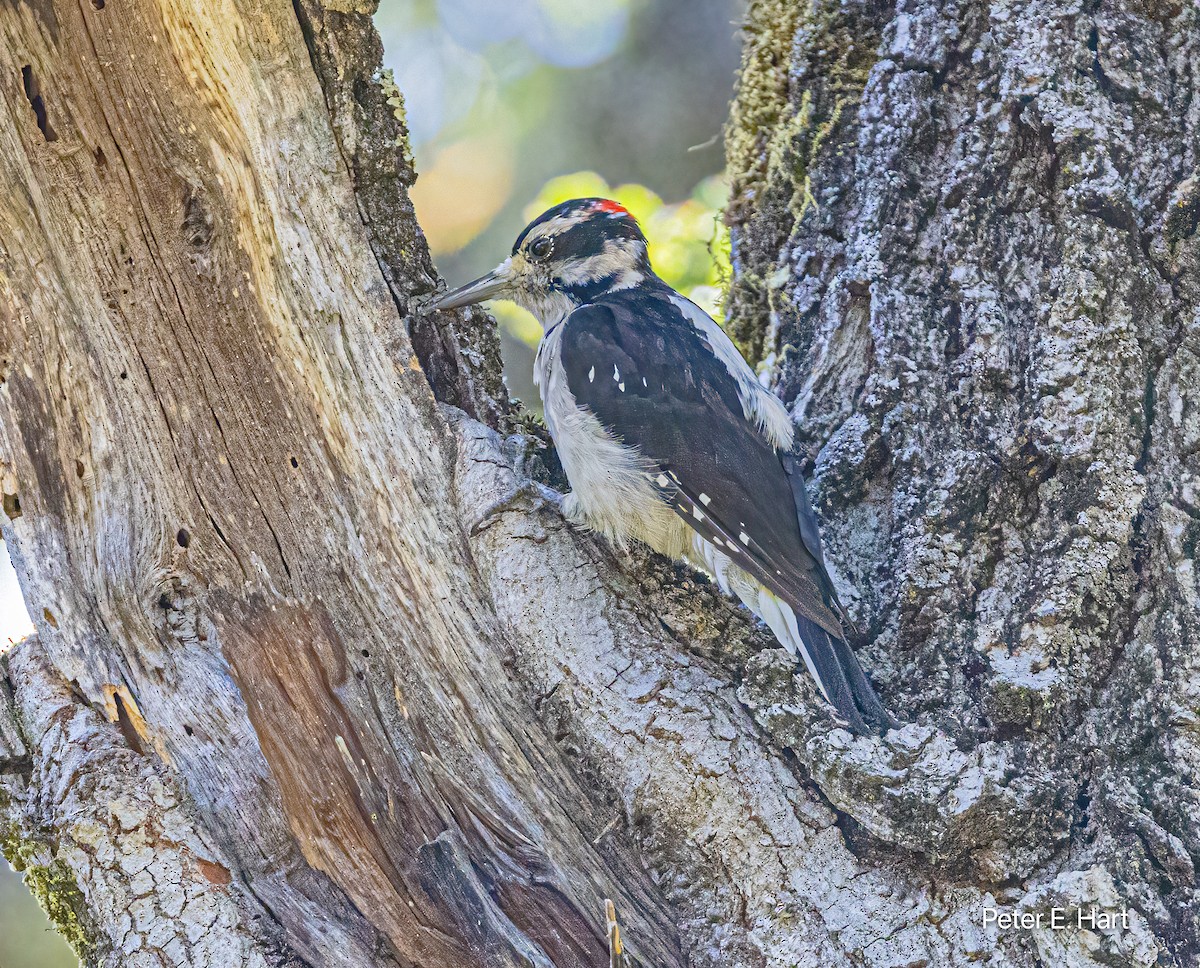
728,0,1200,964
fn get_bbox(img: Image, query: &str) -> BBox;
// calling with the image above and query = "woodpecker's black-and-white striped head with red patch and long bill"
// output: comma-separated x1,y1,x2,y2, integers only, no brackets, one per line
433,198,652,326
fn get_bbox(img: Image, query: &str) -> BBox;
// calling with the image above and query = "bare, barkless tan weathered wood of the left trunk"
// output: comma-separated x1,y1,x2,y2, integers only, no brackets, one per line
0,0,680,966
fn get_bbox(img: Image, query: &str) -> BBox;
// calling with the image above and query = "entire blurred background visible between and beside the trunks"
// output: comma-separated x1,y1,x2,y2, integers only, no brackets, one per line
0,0,744,968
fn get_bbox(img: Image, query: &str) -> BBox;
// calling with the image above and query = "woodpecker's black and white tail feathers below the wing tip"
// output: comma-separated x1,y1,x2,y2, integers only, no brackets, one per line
756,589,895,733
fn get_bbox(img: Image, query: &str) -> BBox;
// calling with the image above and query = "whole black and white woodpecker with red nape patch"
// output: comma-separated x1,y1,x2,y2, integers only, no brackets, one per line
434,198,890,732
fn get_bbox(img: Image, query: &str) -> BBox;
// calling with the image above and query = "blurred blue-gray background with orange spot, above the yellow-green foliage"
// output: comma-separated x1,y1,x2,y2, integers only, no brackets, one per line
376,0,744,265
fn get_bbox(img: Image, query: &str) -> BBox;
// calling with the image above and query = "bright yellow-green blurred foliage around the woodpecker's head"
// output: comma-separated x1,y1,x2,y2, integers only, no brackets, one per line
488,172,730,347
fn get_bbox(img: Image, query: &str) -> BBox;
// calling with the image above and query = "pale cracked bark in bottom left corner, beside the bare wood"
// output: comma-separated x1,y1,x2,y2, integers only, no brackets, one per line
0,638,278,968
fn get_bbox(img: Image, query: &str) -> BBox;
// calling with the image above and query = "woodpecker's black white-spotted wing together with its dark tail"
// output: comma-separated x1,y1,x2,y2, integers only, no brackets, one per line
560,290,886,723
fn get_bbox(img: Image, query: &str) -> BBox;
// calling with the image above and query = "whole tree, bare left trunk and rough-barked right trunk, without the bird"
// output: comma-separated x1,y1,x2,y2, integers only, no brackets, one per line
0,0,1200,968
